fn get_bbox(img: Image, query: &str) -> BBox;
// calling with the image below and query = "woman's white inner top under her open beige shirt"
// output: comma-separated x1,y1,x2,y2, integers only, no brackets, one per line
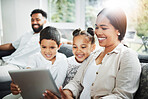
80,60,100,99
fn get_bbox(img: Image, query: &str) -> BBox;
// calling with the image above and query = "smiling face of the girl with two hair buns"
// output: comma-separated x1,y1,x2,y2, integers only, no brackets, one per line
73,35,95,63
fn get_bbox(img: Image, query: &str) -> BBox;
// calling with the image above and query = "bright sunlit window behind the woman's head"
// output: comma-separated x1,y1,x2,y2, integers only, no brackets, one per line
85,0,148,54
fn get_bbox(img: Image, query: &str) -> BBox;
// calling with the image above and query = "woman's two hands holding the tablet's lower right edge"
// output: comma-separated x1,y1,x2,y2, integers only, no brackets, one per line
43,87,73,99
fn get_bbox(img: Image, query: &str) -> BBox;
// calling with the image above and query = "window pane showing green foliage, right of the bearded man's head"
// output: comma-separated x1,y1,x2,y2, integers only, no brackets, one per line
48,0,76,23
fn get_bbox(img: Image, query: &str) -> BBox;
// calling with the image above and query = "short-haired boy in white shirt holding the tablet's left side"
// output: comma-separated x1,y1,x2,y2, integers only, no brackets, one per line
4,26,68,99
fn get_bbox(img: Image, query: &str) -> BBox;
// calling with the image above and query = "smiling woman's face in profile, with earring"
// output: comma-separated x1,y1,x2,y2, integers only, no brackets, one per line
95,15,120,47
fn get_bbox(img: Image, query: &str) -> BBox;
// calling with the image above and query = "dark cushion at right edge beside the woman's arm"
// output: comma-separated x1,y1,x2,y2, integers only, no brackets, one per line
134,63,148,99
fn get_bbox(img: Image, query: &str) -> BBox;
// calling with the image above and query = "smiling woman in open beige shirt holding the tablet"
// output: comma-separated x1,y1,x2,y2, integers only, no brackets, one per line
44,8,141,99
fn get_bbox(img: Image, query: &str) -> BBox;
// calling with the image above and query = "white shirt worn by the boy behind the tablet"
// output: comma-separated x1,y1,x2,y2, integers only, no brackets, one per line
27,52,68,88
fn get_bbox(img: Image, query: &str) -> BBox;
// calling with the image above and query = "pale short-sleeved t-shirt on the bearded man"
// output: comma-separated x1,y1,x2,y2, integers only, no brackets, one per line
3,32,40,68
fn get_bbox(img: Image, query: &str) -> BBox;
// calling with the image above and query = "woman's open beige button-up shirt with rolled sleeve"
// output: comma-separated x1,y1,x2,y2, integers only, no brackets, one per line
64,43,141,99
